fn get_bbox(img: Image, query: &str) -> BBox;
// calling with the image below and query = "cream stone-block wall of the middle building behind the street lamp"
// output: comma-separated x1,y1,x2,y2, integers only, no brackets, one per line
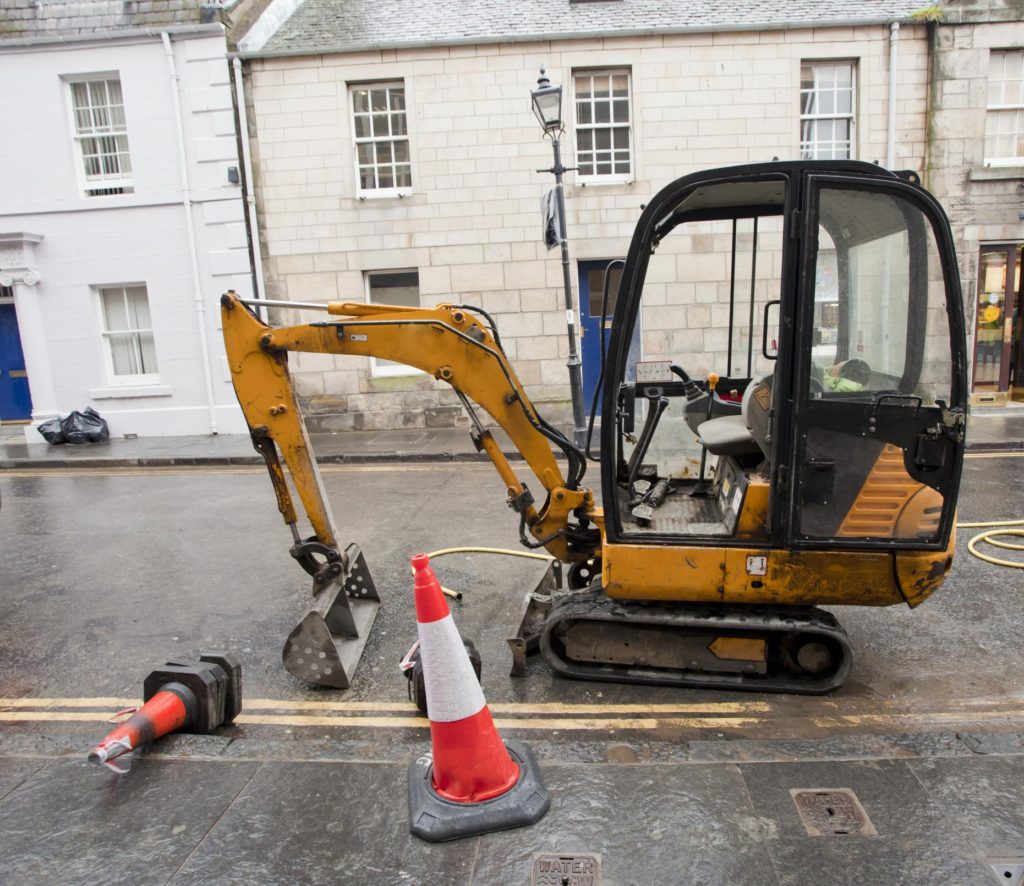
248,26,928,428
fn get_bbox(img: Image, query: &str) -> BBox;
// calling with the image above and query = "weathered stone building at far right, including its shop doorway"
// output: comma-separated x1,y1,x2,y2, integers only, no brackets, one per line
927,0,1024,405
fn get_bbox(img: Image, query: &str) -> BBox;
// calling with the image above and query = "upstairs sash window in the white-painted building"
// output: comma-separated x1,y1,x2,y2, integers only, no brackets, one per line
69,76,135,197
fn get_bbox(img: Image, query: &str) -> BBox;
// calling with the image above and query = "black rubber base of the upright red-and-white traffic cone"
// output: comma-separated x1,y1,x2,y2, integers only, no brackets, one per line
409,739,551,843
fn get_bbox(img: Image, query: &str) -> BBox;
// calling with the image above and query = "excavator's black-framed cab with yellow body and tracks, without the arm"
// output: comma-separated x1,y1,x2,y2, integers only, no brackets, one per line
549,162,967,692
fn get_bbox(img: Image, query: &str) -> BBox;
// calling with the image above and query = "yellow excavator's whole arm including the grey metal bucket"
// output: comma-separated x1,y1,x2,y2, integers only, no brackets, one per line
221,292,600,688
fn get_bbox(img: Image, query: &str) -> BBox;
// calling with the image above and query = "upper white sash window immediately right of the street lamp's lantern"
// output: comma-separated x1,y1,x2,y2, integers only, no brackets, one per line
572,70,633,181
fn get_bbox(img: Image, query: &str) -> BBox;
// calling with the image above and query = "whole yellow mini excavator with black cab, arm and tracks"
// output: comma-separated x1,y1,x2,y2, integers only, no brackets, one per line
222,161,967,693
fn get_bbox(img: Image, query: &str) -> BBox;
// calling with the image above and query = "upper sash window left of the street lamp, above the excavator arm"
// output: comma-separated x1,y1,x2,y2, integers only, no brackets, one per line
351,83,413,197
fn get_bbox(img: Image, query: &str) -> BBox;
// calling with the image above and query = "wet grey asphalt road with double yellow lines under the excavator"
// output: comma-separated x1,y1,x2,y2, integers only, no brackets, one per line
0,454,1024,759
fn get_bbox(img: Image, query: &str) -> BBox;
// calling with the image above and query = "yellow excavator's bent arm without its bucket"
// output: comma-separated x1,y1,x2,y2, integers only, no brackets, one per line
221,292,599,575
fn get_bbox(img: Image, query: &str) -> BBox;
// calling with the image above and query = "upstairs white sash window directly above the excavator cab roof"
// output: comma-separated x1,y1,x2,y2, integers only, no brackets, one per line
800,61,855,160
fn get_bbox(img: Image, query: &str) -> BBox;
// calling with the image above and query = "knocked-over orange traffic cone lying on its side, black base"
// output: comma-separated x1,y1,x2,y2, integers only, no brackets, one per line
89,652,242,774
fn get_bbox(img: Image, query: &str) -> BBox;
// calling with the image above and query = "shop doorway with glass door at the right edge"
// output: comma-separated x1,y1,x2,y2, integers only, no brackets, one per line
972,238,1024,400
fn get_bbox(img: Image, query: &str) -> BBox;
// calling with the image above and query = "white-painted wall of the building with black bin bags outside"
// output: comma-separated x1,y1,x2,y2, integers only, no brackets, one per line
0,26,252,442
